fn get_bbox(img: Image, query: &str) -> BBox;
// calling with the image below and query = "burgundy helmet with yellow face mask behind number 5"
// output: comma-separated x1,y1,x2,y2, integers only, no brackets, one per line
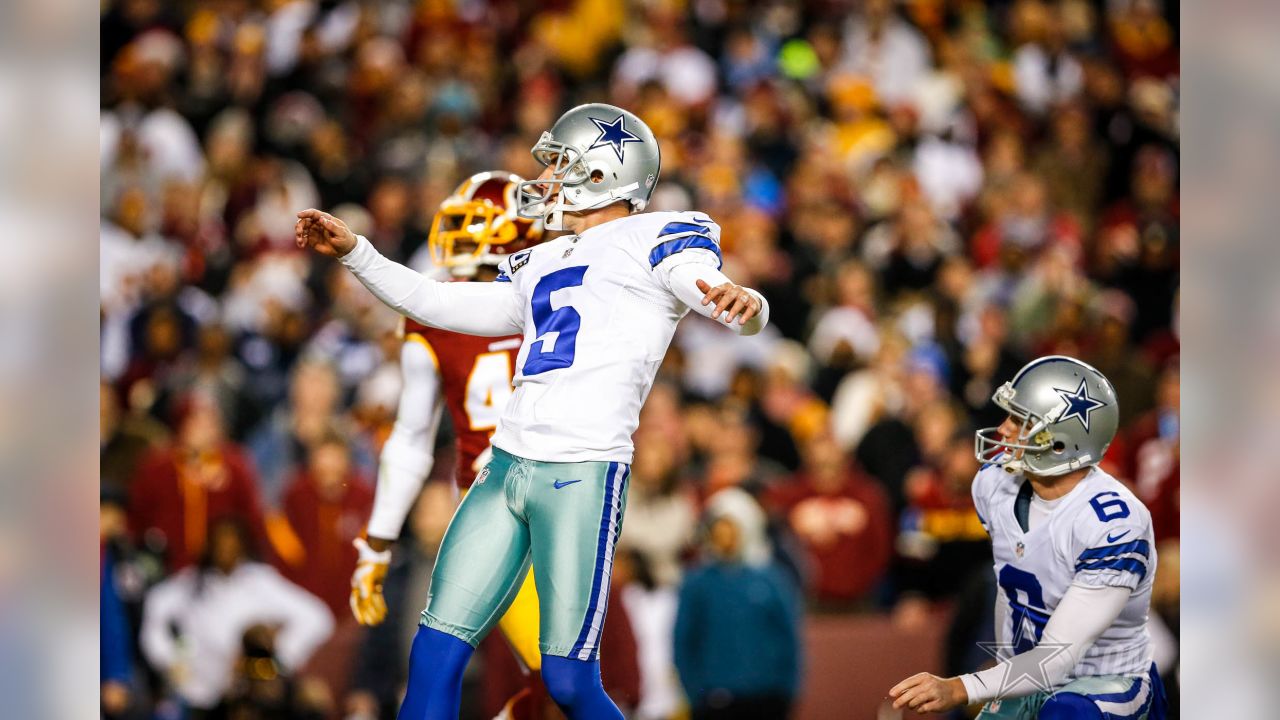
428,172,543,277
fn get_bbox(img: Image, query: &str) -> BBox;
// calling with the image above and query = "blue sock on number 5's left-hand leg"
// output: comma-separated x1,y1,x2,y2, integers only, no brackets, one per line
397,625,475,720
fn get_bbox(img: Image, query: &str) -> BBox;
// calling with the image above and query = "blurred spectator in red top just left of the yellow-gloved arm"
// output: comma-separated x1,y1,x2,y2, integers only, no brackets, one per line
284,430,374,618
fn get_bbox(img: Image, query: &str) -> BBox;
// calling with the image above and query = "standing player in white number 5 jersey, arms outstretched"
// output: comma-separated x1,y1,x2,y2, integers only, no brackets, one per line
296,104,768,720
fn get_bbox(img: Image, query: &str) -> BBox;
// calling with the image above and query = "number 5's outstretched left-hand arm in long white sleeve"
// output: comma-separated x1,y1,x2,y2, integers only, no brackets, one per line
293,209,524,336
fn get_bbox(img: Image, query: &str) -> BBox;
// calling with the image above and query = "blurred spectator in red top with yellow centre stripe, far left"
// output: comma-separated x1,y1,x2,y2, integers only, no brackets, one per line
129,393,266,571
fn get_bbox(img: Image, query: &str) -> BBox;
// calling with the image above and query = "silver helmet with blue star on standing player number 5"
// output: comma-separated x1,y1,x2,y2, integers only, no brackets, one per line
517,102,662,231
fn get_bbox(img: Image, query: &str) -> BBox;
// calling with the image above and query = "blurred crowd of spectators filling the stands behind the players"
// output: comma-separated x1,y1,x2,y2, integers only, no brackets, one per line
100,0,1179,719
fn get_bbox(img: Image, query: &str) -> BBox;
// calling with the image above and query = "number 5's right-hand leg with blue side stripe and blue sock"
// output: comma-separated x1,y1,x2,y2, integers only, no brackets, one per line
529,462,630,720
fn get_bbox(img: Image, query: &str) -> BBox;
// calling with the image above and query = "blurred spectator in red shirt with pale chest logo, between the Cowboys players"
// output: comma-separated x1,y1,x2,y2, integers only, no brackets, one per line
768,432,892,607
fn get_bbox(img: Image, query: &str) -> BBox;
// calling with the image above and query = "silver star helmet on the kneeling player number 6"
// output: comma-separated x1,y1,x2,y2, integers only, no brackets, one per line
974,355,1120,477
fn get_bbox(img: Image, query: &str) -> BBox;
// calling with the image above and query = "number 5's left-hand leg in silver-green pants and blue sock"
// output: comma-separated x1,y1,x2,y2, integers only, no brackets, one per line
401,451,529,720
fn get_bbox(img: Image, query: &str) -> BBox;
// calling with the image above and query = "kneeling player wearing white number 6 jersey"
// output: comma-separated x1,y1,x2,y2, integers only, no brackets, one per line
890,355,1165,720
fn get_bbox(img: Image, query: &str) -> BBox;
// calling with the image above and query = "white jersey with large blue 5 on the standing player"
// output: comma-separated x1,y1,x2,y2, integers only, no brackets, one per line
493,213,721,462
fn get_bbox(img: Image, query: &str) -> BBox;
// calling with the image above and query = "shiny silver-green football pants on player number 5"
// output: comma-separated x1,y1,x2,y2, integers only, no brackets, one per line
422,447,631,660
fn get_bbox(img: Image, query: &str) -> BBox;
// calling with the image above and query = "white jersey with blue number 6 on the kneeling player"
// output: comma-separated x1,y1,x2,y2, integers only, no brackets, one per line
973,465,1156,679
